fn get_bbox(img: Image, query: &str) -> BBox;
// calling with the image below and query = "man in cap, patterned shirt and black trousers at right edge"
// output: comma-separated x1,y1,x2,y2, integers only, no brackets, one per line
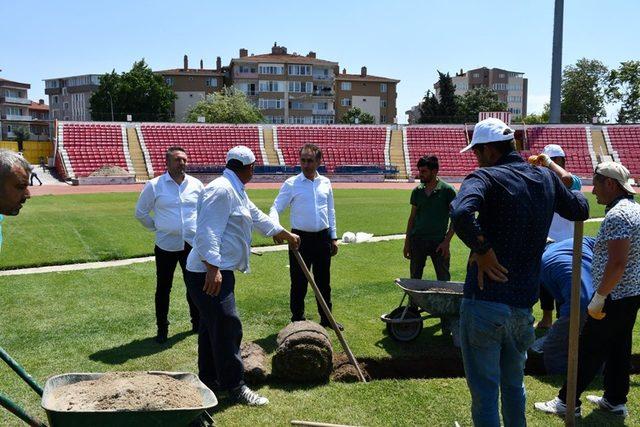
535,162,640,417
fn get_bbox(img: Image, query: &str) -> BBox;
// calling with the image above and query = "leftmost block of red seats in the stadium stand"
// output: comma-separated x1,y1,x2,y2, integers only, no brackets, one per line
56,122,133,178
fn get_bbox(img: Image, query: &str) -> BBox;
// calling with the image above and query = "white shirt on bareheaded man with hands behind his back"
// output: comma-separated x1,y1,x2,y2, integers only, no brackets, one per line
136,172,204,252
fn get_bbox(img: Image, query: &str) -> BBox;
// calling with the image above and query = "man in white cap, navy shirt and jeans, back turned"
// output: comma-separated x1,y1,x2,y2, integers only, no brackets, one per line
451,118,589,426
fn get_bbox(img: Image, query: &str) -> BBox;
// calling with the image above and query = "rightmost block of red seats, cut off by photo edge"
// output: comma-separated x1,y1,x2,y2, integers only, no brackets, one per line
602,125,640,179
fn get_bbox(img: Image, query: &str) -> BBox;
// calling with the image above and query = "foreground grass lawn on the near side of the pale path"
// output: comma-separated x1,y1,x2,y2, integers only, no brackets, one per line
0,239,640,426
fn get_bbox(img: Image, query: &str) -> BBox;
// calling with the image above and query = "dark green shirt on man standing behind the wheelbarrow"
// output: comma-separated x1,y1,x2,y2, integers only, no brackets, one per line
410,178,456,242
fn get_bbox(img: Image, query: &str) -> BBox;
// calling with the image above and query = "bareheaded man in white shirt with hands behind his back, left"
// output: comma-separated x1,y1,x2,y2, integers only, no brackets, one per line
136,147,204,343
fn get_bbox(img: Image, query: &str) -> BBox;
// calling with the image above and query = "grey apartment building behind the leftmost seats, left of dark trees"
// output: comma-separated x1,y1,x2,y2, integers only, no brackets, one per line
44,74,101,121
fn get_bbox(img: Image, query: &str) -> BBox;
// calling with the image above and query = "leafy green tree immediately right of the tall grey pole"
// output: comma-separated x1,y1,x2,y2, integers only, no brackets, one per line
560,58,609,123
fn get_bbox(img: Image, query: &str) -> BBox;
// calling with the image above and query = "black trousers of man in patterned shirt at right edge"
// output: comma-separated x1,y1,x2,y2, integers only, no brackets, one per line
558,296,640,406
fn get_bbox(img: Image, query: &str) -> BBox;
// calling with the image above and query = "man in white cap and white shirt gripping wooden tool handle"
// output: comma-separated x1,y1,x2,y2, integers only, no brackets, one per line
185,145,300,406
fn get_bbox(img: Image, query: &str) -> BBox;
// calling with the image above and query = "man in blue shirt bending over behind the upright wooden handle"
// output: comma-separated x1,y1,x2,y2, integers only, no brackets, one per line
534,237,595,375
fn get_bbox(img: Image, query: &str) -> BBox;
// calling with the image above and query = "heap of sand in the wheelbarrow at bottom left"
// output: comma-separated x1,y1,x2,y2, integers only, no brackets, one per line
47,372,203,411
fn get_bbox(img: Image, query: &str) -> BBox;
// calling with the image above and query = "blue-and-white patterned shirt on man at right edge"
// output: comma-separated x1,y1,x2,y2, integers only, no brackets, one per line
593,196,640,300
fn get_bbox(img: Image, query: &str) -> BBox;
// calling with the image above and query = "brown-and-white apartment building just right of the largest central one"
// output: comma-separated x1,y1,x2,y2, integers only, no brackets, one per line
336,67,400,123
